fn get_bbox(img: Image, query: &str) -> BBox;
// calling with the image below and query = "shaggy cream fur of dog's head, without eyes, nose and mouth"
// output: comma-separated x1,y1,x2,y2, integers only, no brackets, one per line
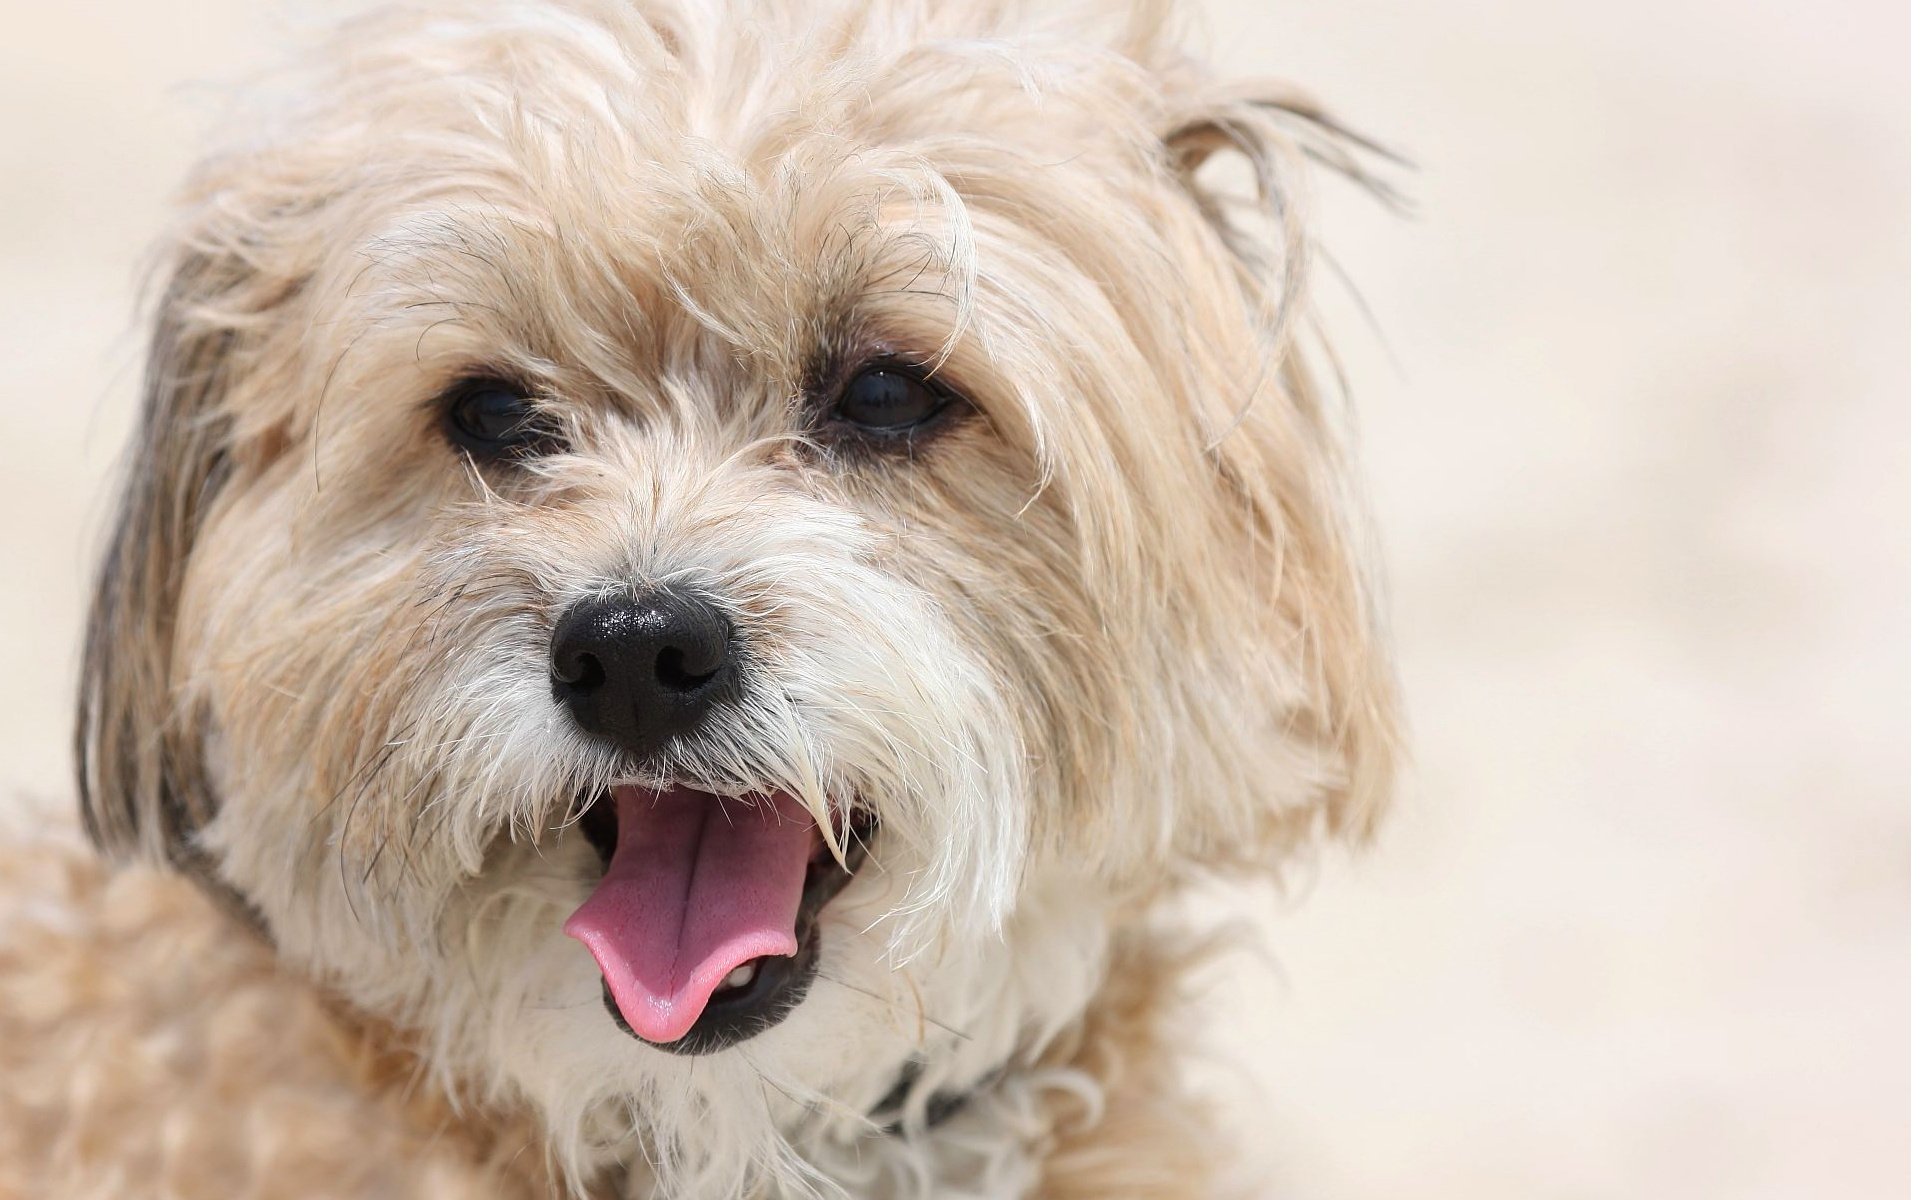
79,0,1394,1196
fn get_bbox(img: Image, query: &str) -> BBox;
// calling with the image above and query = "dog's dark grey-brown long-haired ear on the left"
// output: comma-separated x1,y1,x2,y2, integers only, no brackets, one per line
75,253,236,866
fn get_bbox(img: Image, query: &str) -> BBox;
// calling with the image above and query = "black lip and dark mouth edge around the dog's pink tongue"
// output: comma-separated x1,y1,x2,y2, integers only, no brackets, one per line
580,789,879,1054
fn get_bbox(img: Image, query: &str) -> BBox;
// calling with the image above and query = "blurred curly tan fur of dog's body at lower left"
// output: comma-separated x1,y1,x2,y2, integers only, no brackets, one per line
0,814,555,1200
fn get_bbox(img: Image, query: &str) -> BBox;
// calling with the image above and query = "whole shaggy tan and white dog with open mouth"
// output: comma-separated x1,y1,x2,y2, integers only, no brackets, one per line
0,0,1394,1200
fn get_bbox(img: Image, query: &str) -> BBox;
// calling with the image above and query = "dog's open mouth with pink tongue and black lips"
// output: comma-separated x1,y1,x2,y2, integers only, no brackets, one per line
566,785,876,1054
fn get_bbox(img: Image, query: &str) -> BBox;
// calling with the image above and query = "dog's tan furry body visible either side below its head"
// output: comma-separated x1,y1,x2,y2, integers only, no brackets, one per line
0,814,1235,1200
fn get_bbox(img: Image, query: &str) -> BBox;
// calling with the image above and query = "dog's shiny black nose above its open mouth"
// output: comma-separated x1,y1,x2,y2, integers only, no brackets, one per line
553,588,739,758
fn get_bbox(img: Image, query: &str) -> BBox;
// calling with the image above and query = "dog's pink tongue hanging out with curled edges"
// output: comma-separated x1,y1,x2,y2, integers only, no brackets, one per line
564,787,818,1043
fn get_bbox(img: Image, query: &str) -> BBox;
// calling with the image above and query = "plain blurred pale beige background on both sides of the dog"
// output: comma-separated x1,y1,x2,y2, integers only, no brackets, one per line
0,0,1908,1200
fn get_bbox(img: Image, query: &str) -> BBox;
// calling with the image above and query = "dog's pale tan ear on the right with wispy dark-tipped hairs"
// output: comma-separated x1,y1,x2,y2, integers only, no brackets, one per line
1164,86,1402,856
